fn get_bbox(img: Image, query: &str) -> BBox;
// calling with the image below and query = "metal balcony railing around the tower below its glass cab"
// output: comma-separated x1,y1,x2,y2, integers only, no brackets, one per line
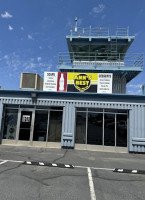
58,52,144,68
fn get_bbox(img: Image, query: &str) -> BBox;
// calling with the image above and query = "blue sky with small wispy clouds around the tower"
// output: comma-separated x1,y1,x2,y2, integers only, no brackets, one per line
0,0,145,94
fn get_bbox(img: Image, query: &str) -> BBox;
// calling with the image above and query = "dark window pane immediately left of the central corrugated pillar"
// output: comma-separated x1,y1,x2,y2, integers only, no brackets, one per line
48,111,62,142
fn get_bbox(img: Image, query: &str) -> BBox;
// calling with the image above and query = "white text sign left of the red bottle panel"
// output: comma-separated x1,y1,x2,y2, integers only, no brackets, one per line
43,72,58,92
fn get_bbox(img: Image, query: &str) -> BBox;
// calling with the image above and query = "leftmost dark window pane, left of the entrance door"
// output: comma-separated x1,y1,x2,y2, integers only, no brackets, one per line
3,109,18,140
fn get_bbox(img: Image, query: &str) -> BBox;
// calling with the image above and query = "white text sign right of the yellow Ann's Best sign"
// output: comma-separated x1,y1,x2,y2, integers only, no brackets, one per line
97,73,113,94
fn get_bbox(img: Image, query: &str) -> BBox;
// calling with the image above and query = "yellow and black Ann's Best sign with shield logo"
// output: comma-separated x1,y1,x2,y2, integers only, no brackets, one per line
67,73,98,92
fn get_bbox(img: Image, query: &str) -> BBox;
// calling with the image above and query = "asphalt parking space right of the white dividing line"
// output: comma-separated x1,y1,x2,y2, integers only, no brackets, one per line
92,170,145,200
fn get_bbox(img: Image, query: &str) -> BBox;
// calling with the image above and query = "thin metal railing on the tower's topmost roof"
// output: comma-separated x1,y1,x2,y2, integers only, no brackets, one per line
70,26,129,37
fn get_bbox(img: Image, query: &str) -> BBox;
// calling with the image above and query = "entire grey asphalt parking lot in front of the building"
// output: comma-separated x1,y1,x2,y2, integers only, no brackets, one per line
0,146,145,200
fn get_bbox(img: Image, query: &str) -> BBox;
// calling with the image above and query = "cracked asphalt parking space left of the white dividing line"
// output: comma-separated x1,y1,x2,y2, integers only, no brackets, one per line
0,161,90,200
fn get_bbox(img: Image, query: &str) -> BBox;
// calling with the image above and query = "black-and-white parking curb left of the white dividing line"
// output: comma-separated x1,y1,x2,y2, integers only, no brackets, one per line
22,161,74,169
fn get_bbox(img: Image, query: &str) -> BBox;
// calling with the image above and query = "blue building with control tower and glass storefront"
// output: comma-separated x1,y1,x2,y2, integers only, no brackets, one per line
0,27,145,153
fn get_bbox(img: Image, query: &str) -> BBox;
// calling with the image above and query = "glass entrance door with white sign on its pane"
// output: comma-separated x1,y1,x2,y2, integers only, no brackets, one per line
18,109,34,144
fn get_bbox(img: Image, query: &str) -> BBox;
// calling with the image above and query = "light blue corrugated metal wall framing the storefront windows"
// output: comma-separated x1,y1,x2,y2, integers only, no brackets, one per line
0,98,145,152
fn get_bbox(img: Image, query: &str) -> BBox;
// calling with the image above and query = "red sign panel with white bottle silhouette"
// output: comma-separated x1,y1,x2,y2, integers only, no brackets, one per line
57,72,67,92
